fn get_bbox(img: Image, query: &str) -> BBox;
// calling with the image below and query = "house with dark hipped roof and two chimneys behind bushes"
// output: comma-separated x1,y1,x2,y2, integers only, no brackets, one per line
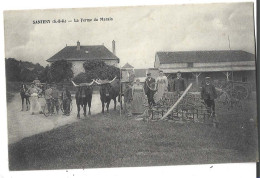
47,40,119,76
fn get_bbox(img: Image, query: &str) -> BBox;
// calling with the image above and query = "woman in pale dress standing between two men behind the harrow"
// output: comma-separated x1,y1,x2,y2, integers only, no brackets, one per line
154,71,168,103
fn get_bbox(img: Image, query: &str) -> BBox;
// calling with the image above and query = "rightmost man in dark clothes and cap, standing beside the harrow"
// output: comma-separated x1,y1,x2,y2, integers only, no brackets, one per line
201,77,217,117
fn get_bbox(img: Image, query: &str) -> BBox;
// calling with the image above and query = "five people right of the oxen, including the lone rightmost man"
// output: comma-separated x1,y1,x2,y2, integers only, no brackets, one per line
124,71,217,116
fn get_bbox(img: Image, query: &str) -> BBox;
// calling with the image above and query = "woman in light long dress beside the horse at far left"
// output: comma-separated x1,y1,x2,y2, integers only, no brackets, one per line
28,84,42,115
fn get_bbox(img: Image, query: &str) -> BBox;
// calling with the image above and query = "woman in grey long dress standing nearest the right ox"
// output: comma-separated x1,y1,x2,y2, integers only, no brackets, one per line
132,79,145,114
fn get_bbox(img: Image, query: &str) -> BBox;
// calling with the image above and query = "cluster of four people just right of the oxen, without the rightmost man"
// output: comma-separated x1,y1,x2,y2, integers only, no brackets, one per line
124,71,186,116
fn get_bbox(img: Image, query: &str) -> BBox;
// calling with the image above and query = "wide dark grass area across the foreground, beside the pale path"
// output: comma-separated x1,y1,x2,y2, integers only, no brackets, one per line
9,105,257,170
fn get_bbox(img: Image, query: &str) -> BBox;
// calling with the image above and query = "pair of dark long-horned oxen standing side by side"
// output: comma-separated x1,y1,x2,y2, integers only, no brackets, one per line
72,77,122,118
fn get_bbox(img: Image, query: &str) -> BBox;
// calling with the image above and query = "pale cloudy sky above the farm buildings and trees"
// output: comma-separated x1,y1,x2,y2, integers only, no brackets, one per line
4,3,255,68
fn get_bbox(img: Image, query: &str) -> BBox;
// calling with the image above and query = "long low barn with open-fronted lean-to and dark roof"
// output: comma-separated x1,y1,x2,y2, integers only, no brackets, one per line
154,50,255,85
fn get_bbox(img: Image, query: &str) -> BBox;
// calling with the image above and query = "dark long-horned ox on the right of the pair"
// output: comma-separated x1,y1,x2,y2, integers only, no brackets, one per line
95,77,120,113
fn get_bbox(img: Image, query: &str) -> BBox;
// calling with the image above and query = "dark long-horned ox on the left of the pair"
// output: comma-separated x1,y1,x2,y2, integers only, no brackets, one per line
72,80,94,119
